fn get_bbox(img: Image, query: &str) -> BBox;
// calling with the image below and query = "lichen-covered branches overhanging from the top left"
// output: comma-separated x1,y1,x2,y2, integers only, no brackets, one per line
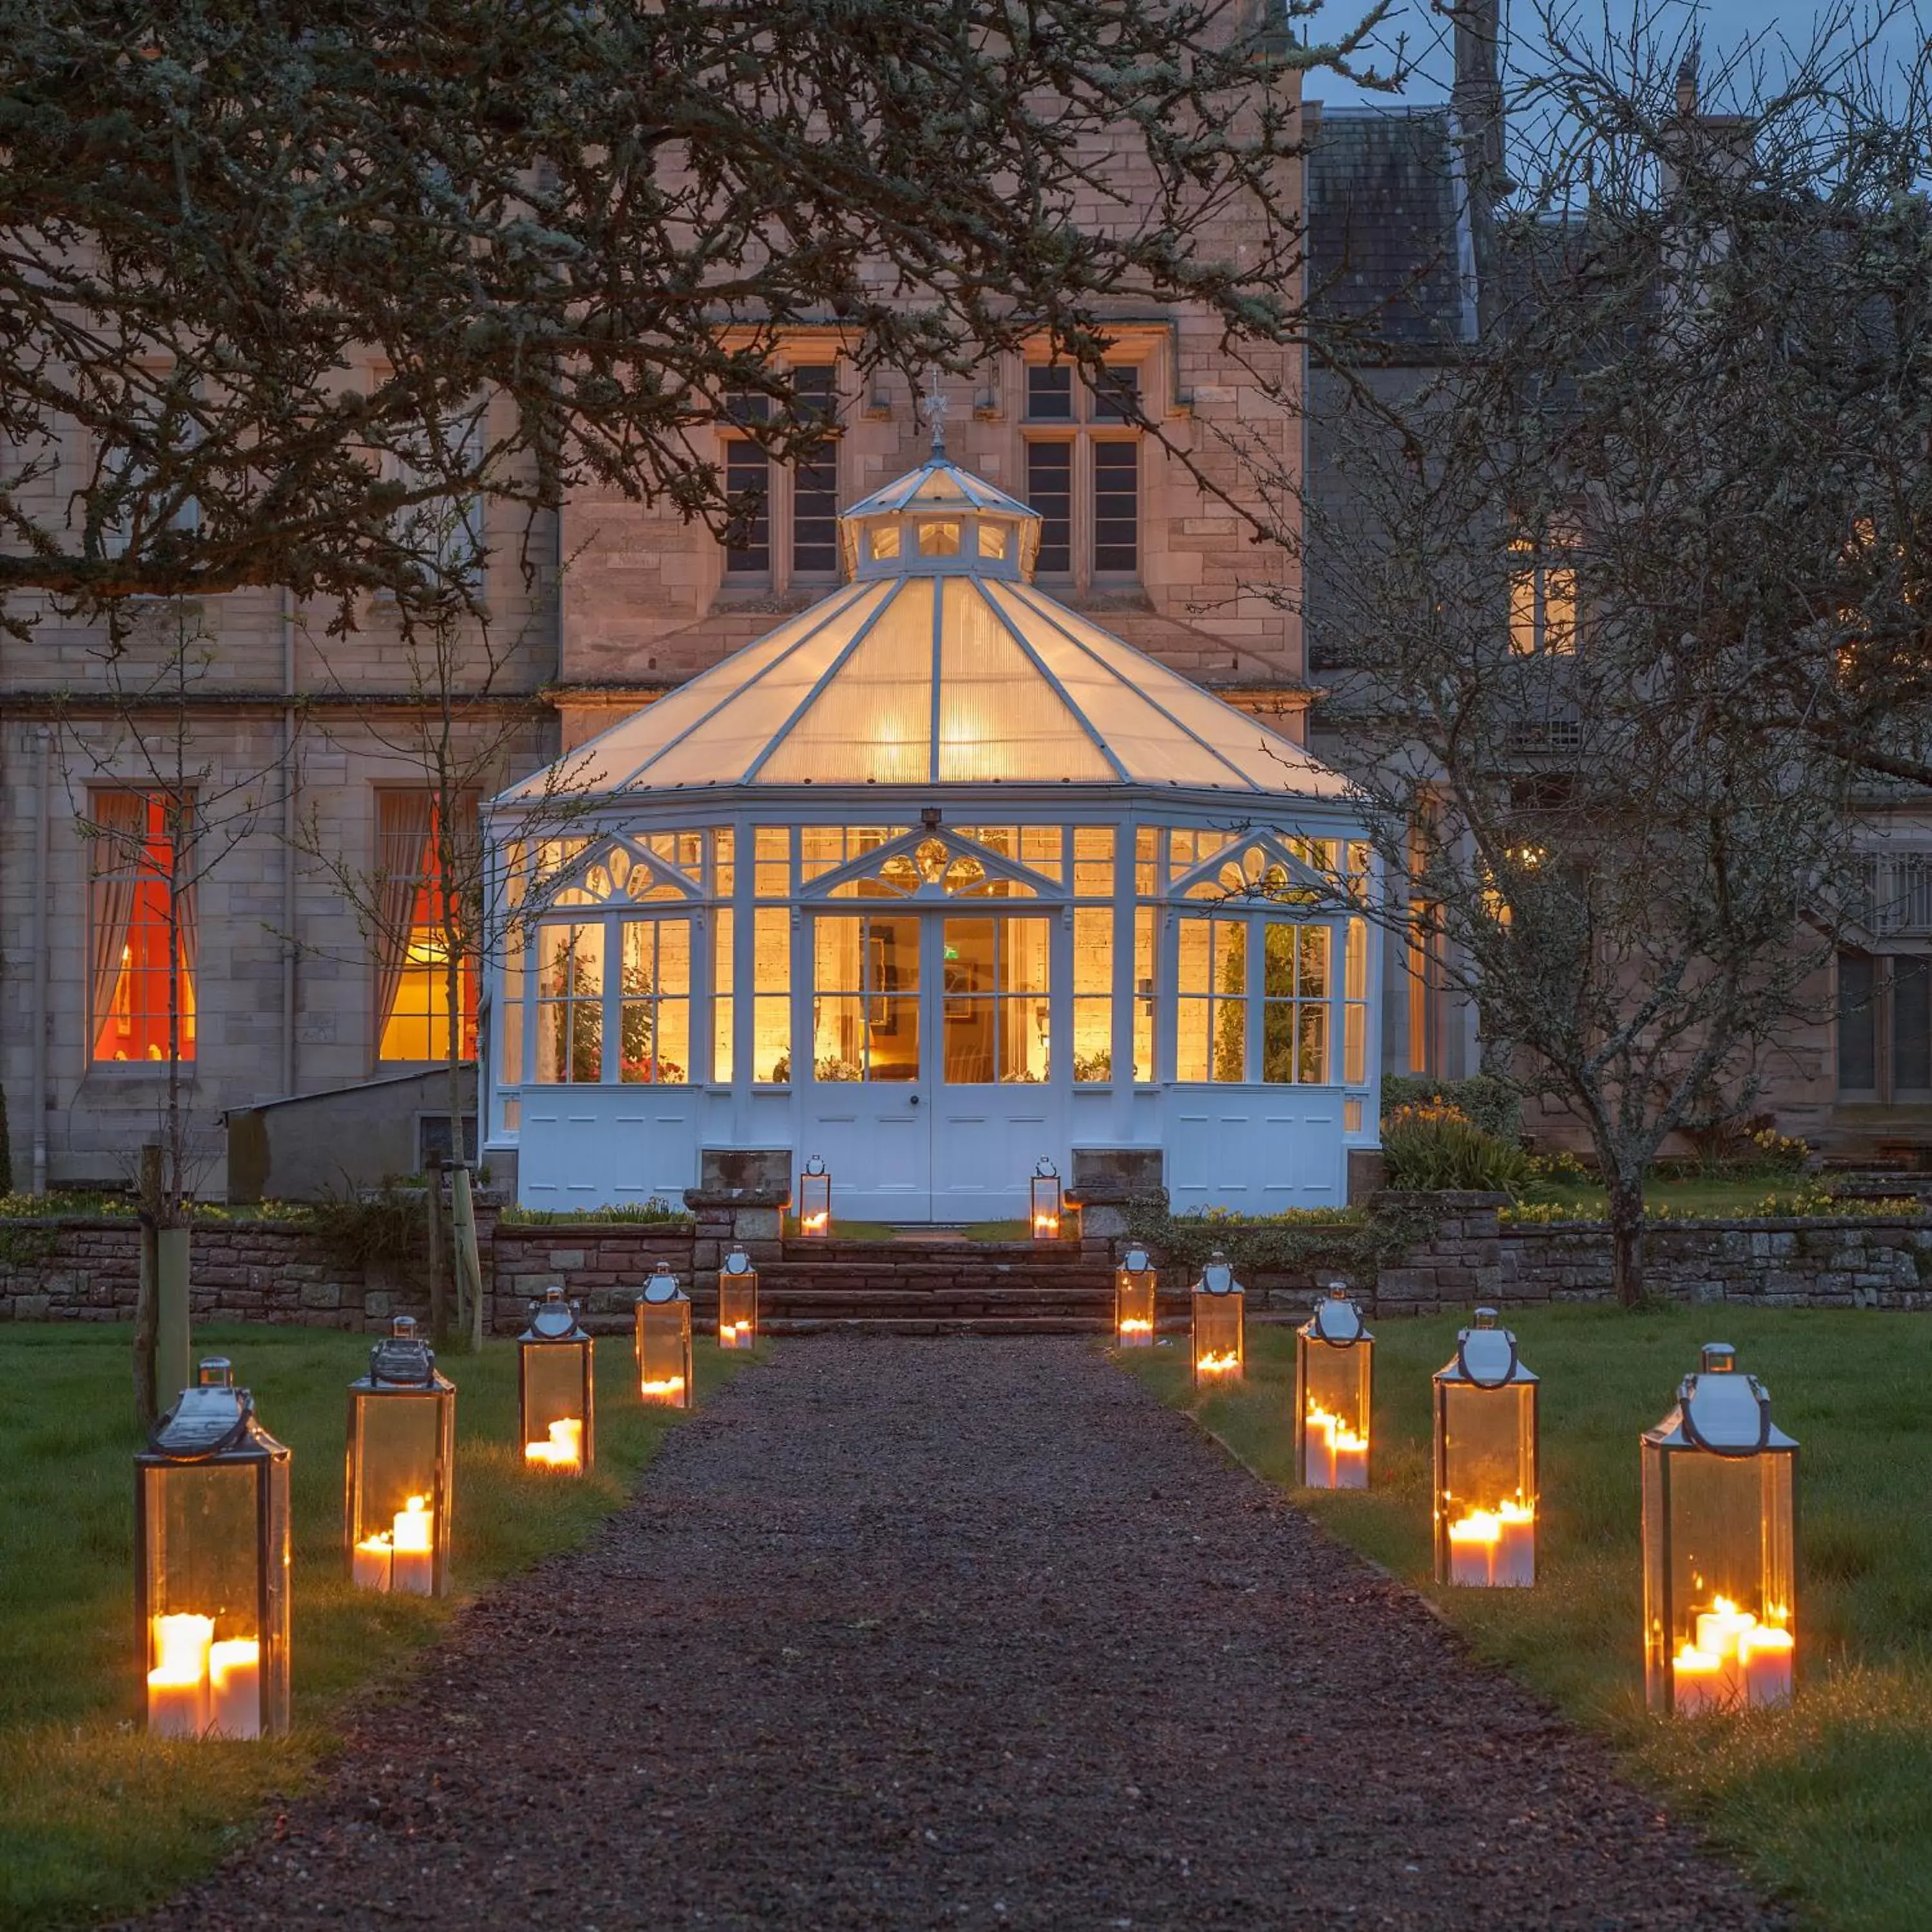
0,0,1381,630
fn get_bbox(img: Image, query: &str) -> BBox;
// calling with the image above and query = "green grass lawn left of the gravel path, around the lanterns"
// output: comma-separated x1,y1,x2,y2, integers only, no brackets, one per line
0,1323,753,1932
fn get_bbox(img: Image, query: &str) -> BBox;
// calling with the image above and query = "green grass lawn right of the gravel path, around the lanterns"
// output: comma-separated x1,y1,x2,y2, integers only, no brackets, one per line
1119,1308,1932,1932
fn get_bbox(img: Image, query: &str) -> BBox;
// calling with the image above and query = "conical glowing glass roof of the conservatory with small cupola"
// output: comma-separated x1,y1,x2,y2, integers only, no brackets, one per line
504,456,1345,804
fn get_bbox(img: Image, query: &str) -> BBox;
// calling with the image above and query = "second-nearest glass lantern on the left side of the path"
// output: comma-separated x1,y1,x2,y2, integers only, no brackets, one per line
342,1316,456,1596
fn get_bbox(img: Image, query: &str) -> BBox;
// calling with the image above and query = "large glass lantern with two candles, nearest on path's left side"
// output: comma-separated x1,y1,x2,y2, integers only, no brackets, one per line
133,1356,290,1737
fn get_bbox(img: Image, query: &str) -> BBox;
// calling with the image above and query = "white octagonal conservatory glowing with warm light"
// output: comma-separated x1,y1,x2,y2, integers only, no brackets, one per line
483,452,1381,1223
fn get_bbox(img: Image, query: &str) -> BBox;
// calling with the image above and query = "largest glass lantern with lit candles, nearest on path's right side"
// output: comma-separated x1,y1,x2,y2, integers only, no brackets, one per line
1642,1343,1799,1716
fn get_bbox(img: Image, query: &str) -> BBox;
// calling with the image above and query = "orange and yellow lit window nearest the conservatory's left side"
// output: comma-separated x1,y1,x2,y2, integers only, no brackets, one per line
377,792,477,1061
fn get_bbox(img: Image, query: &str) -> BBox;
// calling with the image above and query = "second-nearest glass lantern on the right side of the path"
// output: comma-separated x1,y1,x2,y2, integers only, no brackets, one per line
1435,1308,1536,1590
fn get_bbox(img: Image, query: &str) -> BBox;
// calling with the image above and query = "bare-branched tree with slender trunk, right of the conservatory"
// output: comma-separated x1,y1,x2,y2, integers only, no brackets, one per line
1252,15,1932,1302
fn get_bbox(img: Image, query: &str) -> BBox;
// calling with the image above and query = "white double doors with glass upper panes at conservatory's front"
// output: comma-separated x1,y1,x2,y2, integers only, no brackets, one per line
794,900,1072,1221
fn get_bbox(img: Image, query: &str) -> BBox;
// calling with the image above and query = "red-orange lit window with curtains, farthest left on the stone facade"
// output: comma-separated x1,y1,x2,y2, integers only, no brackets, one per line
85,790,195,1063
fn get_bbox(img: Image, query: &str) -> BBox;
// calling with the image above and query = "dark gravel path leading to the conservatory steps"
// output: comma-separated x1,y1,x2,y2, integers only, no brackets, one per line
128,1339,1770,1932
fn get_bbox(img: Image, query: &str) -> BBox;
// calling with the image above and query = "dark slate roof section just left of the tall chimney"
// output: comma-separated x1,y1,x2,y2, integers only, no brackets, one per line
1308,104,1464,363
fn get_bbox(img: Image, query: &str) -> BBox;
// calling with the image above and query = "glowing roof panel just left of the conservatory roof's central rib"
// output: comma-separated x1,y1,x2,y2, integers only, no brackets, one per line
761,578,937,784
